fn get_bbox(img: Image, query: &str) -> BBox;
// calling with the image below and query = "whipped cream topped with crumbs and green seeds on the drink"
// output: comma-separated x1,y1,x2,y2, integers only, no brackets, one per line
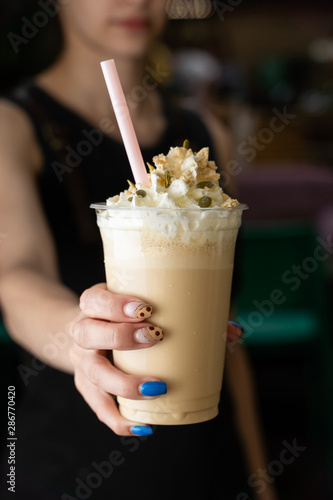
107,147,239,209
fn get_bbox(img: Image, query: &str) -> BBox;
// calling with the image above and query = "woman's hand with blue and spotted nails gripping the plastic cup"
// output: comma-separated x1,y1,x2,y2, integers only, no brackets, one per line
70,284,241,436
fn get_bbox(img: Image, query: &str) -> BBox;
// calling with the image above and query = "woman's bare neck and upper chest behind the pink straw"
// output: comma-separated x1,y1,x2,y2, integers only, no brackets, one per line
36,43,166,145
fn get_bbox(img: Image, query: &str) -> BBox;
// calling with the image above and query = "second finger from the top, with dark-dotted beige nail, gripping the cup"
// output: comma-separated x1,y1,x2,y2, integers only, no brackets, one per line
71,318,164,351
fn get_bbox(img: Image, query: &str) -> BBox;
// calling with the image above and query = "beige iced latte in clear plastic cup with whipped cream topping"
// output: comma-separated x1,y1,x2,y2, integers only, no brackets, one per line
94,148,244,425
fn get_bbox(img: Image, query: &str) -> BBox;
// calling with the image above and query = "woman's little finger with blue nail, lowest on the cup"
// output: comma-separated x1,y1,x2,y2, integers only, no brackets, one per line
74,371,152,436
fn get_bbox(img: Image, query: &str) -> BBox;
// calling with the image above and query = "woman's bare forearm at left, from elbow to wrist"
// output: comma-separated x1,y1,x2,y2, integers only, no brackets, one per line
0,268,79,373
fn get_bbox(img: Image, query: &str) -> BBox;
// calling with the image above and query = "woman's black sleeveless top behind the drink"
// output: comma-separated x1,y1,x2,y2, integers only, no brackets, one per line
1,83,247,500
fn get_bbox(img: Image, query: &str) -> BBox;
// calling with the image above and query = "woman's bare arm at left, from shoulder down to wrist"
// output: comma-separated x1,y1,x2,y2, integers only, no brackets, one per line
0,101,79,371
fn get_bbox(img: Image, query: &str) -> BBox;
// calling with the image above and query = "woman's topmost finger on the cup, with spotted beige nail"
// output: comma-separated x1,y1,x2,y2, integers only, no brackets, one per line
80,283,152,322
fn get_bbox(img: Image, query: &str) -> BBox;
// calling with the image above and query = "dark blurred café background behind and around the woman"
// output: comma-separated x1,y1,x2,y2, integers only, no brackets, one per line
0,0,333,500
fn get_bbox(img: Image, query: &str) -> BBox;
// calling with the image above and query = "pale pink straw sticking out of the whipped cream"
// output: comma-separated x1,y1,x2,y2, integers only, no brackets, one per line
101,59,149,186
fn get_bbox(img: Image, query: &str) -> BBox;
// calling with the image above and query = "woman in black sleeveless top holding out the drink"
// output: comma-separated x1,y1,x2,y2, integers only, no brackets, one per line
0,0,273,500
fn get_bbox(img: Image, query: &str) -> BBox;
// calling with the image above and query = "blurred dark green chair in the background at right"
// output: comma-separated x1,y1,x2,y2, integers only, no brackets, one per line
237,222,333,488
